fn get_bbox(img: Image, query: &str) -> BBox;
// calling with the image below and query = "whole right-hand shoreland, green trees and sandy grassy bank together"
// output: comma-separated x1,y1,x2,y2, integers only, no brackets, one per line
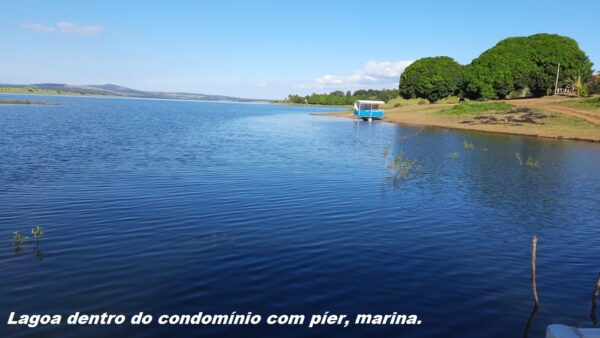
296,34,600,142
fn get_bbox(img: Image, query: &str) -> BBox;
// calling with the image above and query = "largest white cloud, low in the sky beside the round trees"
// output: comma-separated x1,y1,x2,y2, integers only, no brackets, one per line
300,60,413,89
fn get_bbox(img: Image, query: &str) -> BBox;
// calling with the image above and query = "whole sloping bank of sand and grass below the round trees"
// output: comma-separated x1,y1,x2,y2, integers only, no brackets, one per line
328,97,600,142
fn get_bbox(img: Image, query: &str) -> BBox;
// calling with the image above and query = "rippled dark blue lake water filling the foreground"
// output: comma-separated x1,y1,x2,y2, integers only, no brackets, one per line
0,95,600,338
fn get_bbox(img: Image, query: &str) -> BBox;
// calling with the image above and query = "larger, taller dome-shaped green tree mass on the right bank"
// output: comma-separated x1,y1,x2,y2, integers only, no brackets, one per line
464,34,592,99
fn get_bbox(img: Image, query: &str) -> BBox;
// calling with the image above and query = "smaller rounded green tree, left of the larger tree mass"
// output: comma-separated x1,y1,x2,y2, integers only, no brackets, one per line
399,56,463,102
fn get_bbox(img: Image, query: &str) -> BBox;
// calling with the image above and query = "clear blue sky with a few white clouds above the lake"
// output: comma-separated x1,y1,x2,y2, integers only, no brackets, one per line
0,0,600,98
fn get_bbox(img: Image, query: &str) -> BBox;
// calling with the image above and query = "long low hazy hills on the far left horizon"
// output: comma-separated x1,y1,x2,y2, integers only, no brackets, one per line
0,83,270,102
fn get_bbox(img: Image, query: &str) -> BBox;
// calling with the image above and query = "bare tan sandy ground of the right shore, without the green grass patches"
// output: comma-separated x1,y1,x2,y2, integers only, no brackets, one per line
324,97,600,142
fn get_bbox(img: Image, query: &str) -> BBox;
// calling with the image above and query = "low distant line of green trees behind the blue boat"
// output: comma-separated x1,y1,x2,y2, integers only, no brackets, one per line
286,89,398,106
